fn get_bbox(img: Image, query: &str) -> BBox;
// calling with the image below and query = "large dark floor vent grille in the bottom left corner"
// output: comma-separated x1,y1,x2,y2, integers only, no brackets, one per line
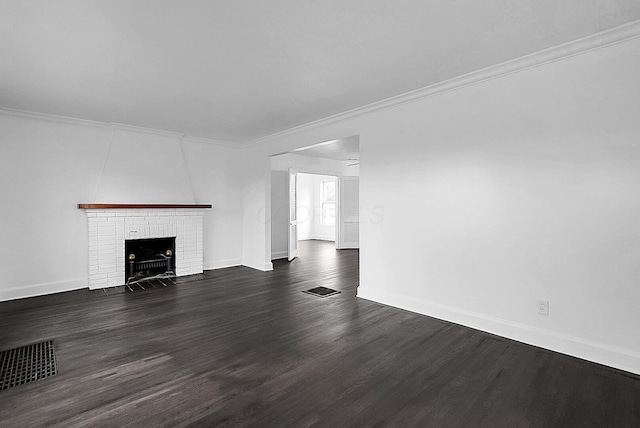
0,340,57,391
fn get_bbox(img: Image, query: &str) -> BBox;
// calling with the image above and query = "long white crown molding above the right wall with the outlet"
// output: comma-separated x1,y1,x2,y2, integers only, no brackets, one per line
241,20,640,149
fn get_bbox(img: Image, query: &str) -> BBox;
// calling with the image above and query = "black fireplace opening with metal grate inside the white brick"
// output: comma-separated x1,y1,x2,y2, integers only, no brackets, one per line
124,237,176,285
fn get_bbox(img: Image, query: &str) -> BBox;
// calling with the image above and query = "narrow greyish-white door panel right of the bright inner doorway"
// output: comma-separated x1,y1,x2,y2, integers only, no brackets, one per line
336,177,360,249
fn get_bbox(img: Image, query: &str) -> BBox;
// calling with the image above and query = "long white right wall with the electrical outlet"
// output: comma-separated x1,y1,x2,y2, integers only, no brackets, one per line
242,39,640,373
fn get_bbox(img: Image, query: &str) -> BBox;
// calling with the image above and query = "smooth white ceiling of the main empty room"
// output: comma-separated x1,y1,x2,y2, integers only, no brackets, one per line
0,0,640,143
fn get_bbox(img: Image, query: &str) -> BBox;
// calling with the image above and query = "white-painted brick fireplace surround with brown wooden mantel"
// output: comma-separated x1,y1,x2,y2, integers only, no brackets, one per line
78,204,211,289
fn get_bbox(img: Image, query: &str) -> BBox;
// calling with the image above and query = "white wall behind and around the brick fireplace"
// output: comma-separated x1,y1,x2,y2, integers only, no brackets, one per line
0,111,242,300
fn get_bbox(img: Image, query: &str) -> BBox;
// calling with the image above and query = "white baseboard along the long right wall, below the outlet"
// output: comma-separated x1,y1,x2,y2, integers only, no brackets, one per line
358,287,640,374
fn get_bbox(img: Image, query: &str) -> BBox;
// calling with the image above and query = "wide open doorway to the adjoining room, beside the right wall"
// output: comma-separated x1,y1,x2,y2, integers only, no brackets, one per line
271,136,359,260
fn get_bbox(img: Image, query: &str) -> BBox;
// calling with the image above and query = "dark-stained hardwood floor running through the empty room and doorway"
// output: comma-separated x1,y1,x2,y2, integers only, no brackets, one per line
0,241,640,427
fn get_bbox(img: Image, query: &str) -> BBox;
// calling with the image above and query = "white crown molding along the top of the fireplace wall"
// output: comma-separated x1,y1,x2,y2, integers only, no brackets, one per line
0,106,240,149
